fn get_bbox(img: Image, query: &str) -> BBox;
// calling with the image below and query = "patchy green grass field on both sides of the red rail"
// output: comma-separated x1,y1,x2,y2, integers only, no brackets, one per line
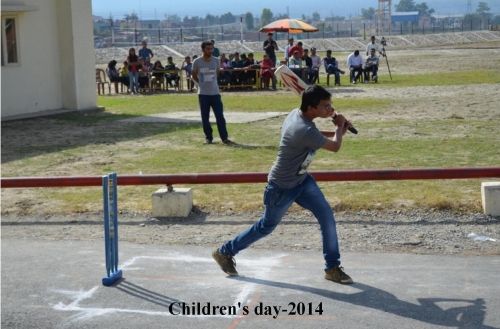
2,64,500,213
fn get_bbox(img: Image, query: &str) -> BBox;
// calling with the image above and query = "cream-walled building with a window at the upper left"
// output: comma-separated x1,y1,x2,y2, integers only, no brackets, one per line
1,0,97,120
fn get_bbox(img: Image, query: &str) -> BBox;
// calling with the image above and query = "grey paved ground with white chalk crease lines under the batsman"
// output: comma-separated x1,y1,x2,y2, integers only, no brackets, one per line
1,239,500,329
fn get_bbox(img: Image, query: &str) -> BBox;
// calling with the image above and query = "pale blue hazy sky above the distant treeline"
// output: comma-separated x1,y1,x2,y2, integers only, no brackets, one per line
92,0,500,19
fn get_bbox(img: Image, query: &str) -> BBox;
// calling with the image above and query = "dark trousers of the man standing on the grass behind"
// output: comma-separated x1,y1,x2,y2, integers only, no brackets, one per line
198,95,228,141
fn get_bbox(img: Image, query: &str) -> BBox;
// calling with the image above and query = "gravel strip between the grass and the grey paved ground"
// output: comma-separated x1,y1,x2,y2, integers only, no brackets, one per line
2,209,500,255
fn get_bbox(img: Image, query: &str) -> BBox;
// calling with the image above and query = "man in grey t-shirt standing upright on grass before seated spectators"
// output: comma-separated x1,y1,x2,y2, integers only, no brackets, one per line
192,41,231,144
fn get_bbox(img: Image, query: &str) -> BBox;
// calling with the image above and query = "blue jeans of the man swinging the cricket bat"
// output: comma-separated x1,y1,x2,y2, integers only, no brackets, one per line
219,175,340,270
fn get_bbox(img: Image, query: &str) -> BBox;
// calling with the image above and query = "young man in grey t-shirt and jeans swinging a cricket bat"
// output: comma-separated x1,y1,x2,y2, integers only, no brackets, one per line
212,85,352,284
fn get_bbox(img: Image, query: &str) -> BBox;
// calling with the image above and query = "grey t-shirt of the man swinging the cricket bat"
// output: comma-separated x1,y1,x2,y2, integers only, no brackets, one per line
268,109,326,189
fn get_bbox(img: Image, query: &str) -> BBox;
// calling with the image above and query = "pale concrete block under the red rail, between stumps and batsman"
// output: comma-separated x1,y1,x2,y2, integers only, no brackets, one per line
152,187,193,217
